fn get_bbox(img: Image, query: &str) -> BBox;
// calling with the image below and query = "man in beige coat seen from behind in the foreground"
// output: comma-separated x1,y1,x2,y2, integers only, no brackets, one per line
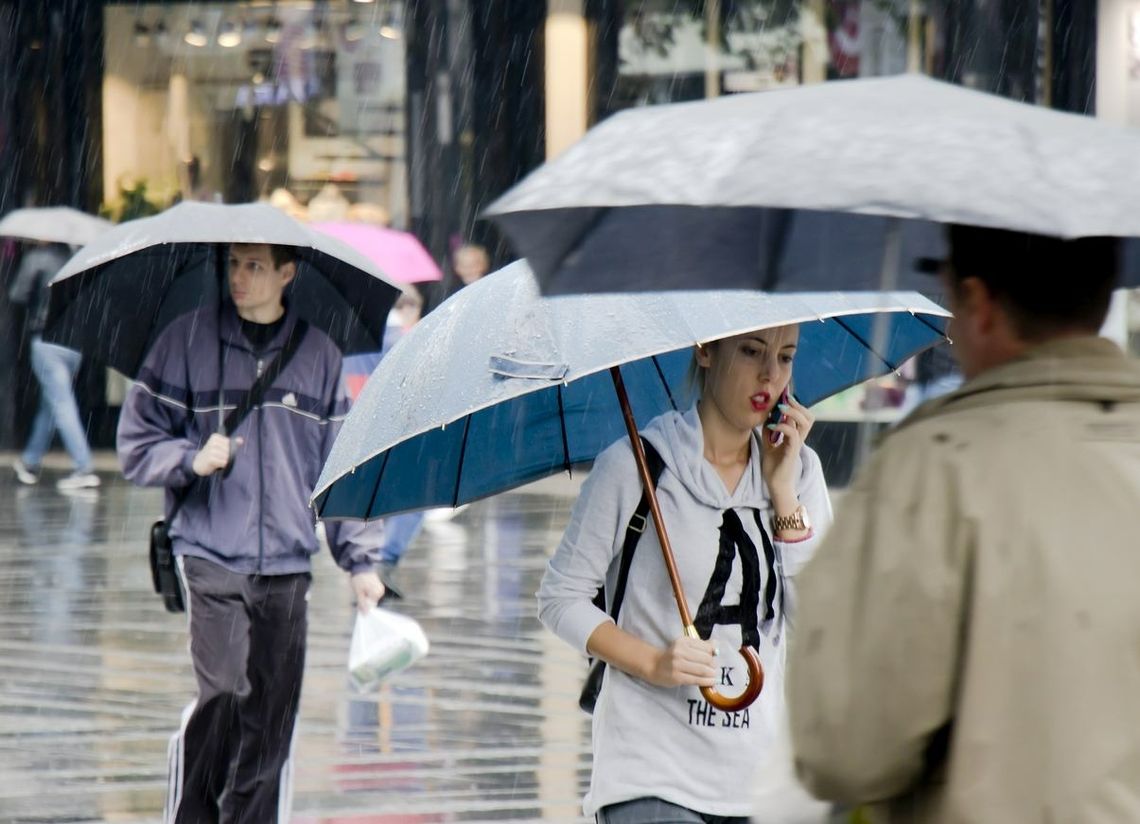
788,227,1140,824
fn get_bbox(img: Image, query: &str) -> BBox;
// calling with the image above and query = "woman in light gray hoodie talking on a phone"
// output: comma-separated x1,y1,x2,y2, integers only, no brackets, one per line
538,326,831,824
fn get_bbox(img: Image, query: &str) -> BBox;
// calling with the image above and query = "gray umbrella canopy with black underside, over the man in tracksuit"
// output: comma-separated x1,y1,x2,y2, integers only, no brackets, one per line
43,203,399,376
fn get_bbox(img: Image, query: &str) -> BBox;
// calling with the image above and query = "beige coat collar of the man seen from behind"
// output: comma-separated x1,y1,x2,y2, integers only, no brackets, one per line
899,336,1140,429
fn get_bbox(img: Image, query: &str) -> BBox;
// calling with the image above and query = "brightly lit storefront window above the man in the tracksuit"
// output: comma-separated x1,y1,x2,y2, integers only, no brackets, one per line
103,0,407,228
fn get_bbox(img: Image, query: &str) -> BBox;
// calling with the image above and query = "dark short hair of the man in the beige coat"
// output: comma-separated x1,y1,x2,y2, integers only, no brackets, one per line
950,225,1119,341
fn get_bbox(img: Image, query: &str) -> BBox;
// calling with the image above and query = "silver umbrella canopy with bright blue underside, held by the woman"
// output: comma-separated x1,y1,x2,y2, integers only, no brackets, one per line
315,261,947,519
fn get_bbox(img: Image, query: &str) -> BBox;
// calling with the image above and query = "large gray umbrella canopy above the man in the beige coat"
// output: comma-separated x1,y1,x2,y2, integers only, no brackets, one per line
486,75,1140,294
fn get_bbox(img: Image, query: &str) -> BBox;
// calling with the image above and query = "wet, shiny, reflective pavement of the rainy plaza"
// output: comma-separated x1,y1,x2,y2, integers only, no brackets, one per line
0,462,589,824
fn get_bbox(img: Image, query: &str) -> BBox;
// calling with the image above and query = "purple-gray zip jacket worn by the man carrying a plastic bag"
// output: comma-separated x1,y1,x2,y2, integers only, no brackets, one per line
119,302,380,576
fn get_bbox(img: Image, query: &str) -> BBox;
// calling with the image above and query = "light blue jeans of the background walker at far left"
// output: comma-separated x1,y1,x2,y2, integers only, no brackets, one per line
21,335,91,473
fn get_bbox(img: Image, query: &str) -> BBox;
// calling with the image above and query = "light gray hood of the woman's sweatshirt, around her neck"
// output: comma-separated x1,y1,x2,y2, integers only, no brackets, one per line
642,403,766,509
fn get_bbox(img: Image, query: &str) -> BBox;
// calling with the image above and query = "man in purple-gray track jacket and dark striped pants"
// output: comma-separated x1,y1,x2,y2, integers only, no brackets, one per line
119,245,384,824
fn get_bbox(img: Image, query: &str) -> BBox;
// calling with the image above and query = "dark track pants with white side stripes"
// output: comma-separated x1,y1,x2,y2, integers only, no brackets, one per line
164,557,310,824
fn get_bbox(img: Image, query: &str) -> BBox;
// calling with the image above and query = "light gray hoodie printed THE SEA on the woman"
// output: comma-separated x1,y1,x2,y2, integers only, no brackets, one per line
538,407,831,816
